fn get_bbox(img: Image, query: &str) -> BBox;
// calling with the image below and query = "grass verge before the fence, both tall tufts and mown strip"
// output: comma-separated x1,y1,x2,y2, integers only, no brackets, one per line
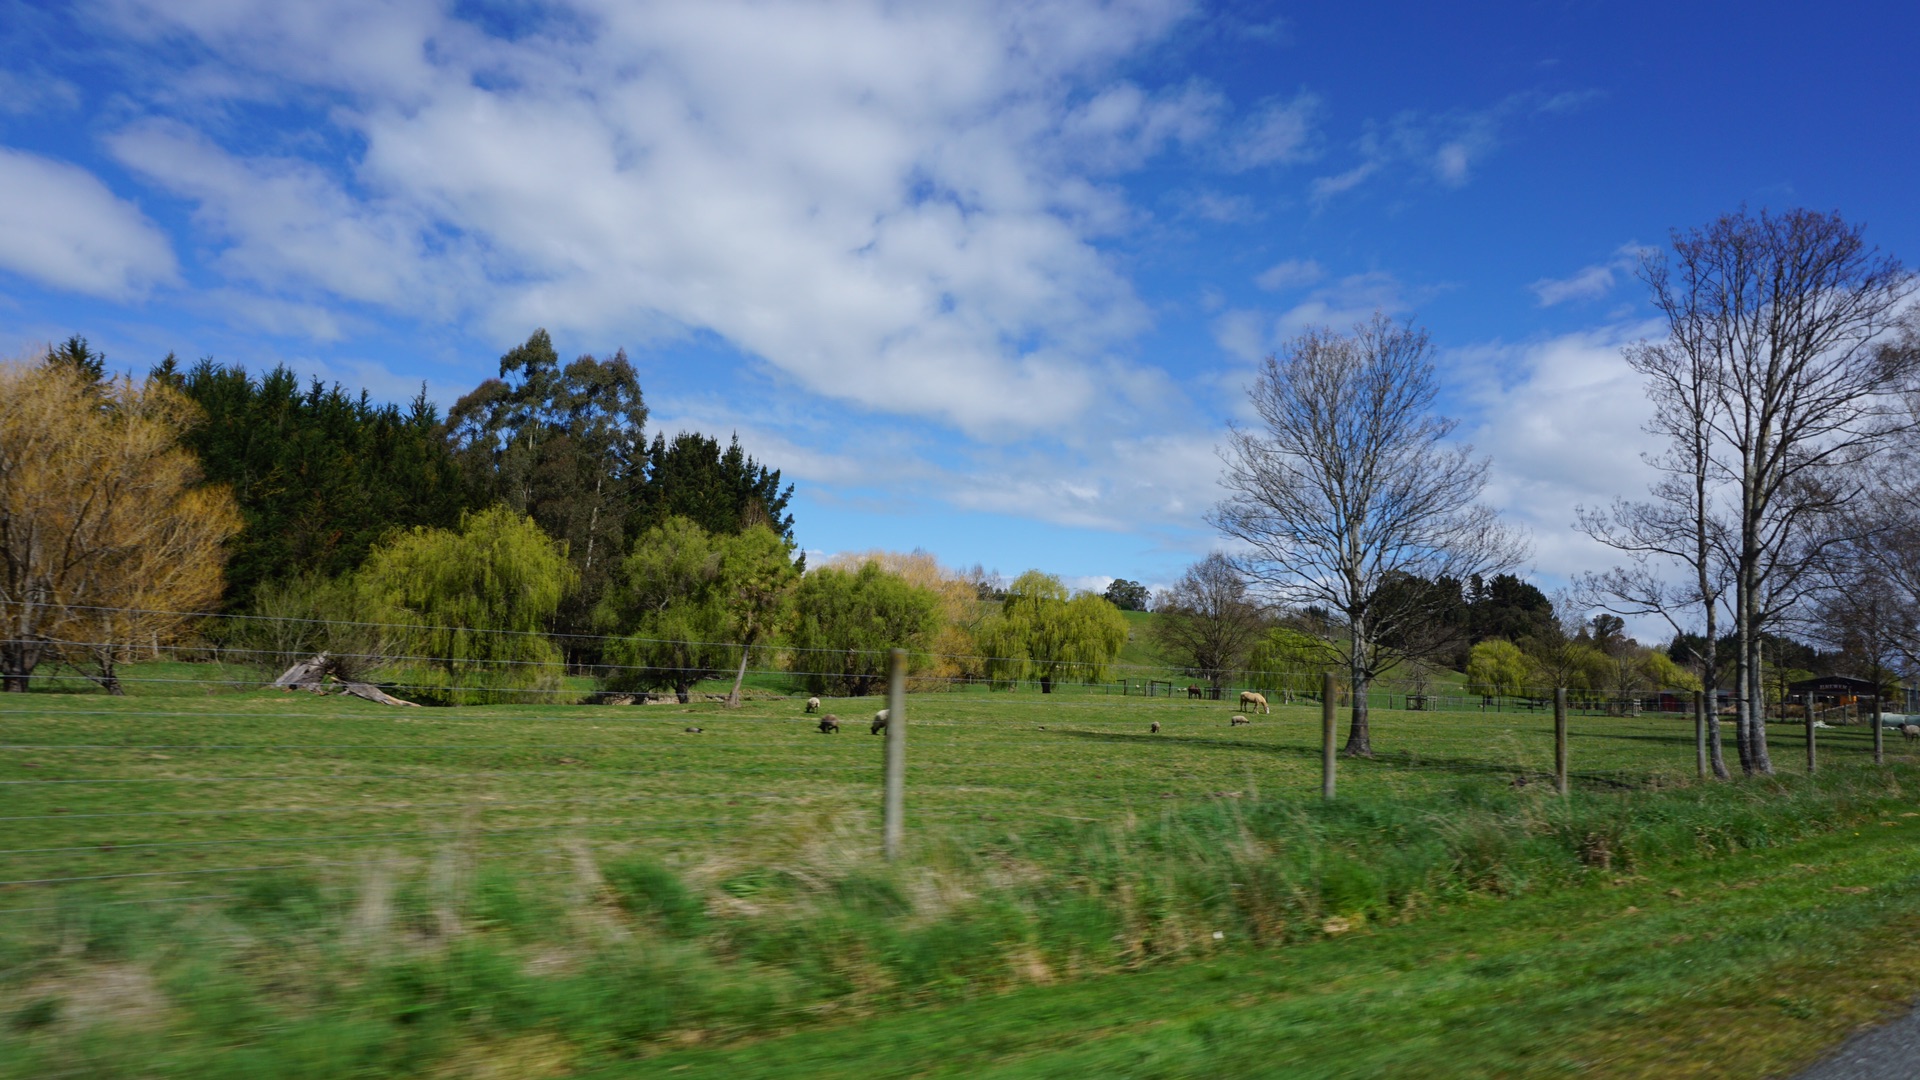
0,767,1920,1078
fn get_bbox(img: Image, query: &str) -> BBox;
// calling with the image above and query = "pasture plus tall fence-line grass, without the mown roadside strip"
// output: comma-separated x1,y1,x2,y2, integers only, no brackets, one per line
0,665,1920,1076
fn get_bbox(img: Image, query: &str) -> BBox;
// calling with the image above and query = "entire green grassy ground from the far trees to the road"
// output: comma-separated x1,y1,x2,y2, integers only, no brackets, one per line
0,665,1920,1080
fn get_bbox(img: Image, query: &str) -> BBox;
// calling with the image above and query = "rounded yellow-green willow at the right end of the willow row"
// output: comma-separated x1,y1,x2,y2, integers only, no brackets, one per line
979,571,1127,694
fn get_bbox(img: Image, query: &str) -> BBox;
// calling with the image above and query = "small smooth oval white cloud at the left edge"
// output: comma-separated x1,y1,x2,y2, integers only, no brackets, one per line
0,146,179,300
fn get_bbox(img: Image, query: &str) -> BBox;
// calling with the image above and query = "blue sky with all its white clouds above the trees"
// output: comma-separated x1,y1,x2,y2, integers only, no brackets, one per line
0,0,1920,586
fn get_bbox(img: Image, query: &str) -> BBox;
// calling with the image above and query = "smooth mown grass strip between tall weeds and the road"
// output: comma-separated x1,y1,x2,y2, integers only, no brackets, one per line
637,817,1920,1078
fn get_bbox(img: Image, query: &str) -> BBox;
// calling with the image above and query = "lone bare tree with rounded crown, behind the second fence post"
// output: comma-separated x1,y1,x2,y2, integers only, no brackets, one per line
1210,313,1524,757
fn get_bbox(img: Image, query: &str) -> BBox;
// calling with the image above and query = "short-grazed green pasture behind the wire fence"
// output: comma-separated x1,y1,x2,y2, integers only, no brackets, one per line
0,664,1870,890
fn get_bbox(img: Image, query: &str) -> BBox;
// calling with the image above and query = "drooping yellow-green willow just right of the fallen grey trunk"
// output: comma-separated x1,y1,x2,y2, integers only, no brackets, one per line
357,505,576,705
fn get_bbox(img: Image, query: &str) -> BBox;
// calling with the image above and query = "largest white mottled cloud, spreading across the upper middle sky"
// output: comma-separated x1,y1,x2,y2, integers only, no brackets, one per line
97,0,1205,434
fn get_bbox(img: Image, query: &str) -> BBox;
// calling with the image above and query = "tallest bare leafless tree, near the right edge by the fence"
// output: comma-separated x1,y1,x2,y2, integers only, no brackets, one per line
1605,209,1920,774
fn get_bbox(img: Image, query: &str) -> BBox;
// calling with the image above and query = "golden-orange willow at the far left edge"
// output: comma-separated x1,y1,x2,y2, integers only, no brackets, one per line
0,353,240,694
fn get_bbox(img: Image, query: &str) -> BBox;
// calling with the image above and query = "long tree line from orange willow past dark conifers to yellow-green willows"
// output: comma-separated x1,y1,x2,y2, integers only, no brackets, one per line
0,331,1127,703
